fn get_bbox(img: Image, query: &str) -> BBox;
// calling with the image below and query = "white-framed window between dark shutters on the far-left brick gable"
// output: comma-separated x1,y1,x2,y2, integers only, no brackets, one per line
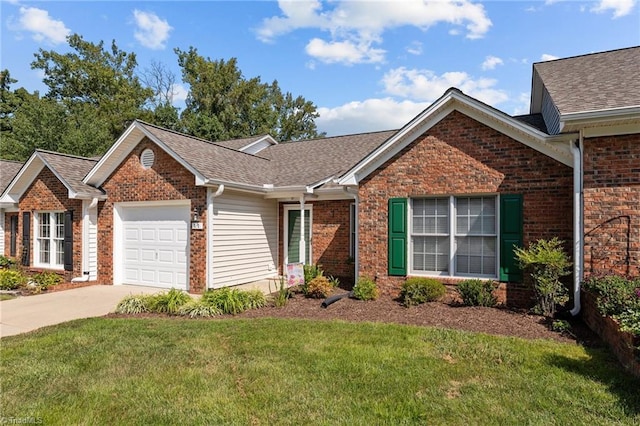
36,212,64,268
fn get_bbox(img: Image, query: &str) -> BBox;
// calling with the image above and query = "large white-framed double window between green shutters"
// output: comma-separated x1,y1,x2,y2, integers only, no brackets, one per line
411,196,498,277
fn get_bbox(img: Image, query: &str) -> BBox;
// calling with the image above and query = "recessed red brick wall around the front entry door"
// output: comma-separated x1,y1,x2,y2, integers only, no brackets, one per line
278,200,354,284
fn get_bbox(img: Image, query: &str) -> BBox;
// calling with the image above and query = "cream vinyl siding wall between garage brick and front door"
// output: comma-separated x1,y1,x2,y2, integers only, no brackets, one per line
210,192,278,288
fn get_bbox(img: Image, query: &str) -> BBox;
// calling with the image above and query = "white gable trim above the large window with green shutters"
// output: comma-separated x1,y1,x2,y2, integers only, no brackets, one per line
337,91,573,185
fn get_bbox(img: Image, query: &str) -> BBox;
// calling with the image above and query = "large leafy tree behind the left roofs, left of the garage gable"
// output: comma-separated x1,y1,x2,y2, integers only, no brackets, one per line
31,34,153,155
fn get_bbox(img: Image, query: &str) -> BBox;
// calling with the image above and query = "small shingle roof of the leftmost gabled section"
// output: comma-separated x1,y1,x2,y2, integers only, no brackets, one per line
37,150,104,196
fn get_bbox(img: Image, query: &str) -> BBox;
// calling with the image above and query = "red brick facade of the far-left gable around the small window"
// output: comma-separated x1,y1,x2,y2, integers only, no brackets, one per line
17,167,82,281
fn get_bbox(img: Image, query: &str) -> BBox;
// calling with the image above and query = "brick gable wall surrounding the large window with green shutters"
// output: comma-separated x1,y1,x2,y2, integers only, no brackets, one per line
358,111,573,302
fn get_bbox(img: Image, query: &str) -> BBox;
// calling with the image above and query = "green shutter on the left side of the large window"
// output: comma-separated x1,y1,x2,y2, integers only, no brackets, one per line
389,198,407,276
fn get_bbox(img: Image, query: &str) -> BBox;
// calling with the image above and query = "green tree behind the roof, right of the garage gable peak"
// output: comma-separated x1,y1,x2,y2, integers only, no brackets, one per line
175,47,319,141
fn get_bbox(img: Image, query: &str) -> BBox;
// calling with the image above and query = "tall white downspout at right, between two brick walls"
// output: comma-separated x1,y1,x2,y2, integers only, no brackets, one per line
570,135,584,316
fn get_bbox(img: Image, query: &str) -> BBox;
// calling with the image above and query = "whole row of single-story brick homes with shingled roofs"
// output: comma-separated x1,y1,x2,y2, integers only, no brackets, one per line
0,47,640,310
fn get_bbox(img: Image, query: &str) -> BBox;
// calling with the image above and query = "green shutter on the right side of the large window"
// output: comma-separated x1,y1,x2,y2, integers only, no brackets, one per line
500,194,523,282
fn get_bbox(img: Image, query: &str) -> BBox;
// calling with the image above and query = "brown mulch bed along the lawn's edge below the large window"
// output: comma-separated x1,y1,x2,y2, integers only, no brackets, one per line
237,292,601,346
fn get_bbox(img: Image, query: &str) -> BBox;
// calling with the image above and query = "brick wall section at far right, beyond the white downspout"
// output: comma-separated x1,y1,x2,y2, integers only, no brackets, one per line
584,134,640,276
